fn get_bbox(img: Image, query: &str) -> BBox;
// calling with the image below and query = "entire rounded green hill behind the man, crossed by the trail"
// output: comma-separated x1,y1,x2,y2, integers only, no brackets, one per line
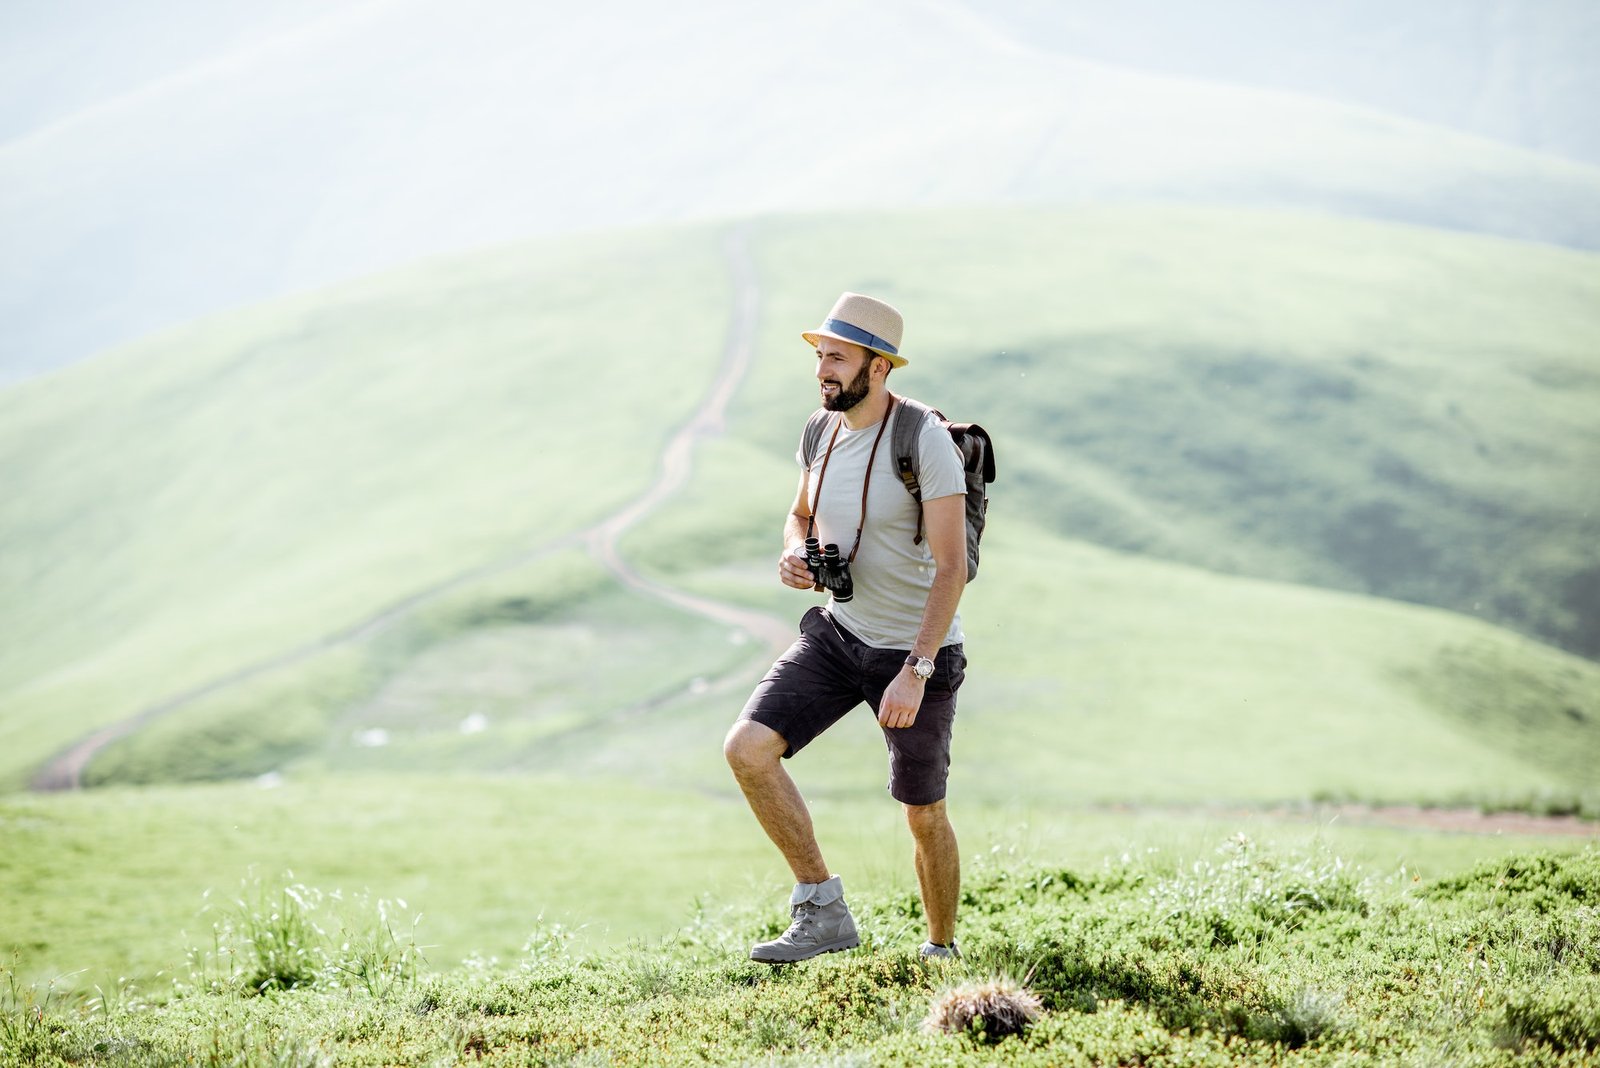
0,208,1600,799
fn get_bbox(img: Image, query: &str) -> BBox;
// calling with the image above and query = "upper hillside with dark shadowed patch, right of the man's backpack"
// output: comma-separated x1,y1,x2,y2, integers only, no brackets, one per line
723,209,1600,656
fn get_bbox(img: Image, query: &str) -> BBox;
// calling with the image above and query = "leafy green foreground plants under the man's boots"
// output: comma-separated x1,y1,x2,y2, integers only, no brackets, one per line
0,835,1600,1065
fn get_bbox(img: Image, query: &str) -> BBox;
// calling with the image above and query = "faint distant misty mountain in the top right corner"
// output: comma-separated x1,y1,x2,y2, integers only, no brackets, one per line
984,0,1600,163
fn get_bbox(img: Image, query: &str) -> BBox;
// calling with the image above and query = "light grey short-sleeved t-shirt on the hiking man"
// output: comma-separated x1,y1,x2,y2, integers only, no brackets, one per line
795,404,966,649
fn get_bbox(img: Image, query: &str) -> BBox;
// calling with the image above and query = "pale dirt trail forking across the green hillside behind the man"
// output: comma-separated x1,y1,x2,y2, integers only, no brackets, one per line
29,227,794,791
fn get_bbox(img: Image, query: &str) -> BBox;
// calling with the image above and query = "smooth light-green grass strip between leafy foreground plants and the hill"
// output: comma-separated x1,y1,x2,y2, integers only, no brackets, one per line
0,770,1584,991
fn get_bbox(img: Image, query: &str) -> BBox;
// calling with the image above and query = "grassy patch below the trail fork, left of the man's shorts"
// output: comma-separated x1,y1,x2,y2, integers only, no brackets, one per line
73,550,750,785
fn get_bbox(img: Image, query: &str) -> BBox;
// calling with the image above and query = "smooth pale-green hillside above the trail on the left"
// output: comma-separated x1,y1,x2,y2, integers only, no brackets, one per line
0,229,730,785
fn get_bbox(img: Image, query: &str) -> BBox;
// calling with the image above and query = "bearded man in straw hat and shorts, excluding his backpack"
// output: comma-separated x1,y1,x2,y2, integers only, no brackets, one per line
723,293,966,964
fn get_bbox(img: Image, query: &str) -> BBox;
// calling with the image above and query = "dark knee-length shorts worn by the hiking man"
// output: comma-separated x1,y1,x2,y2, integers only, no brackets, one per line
739,608,966,804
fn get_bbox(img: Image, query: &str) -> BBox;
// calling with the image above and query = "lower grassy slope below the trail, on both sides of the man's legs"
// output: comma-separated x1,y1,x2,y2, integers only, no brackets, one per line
88,518,1600,812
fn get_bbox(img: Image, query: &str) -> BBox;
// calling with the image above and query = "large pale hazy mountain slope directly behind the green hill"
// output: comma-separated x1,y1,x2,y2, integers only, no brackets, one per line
9,0,1600,381
